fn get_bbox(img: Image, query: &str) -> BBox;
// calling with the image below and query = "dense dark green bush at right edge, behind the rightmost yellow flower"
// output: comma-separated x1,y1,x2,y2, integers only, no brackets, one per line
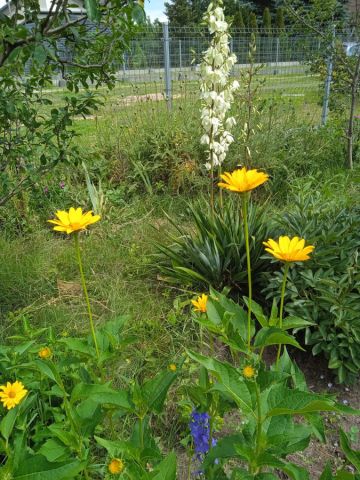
264,187,360,383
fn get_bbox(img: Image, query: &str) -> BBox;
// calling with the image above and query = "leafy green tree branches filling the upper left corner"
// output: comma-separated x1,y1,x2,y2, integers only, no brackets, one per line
0,0,144,206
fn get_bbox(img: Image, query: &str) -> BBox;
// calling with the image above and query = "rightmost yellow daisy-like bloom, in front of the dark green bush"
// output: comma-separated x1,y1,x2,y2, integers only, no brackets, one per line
263,236,315,262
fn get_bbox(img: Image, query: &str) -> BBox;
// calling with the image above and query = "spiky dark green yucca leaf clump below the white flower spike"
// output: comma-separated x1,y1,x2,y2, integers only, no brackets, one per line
156,198,270,293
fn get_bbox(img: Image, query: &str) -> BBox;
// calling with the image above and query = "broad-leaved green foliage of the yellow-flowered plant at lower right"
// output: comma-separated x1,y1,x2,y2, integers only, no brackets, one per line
188,291,358,480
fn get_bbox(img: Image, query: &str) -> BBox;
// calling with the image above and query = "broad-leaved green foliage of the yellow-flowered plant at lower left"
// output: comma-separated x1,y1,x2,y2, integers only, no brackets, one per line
0,317,179,480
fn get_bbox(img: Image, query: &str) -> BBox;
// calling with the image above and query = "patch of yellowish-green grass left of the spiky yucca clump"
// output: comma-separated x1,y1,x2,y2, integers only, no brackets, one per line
0,193,200,372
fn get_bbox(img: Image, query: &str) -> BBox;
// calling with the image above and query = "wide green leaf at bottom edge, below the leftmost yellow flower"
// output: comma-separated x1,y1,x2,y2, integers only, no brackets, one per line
13,455,86,480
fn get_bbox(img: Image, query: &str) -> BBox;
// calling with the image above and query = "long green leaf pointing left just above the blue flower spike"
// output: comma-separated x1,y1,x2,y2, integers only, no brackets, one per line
187,351,256,417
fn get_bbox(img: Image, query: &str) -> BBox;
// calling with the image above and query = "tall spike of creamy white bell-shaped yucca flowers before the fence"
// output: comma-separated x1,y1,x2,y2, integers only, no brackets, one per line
200,0,240,170
